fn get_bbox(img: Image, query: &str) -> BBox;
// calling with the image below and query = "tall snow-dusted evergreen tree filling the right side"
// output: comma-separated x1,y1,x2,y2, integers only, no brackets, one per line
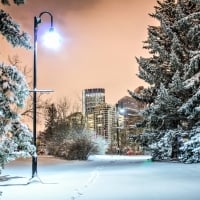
129,0,200,162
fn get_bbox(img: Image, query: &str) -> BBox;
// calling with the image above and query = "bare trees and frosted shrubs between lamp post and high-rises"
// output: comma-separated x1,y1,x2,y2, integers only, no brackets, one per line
37,98,107,160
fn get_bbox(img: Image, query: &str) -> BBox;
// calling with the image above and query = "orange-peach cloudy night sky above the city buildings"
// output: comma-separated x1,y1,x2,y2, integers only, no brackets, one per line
0,0,159,104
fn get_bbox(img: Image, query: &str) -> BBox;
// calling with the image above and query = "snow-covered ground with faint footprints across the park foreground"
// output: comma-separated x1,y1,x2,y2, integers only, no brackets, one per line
0,155,200,200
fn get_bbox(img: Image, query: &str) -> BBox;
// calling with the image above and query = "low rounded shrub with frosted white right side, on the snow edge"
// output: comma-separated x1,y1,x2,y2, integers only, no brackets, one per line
42,130,108,160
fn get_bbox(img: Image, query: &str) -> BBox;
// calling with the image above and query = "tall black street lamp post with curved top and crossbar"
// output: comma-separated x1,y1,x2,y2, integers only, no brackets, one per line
32,11,58,179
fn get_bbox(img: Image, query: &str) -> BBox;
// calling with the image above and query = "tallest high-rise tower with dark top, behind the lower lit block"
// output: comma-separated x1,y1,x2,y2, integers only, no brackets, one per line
82,88,105,116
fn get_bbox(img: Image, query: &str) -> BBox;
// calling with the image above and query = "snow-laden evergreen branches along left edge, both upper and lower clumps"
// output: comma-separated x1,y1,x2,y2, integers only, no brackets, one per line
0,0,35,169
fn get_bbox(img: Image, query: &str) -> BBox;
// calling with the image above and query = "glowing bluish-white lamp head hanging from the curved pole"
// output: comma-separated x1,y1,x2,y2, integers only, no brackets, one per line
43,27,61,49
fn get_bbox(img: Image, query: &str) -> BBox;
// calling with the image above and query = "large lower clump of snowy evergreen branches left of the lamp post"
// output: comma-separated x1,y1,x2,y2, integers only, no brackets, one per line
0,64,35,168
